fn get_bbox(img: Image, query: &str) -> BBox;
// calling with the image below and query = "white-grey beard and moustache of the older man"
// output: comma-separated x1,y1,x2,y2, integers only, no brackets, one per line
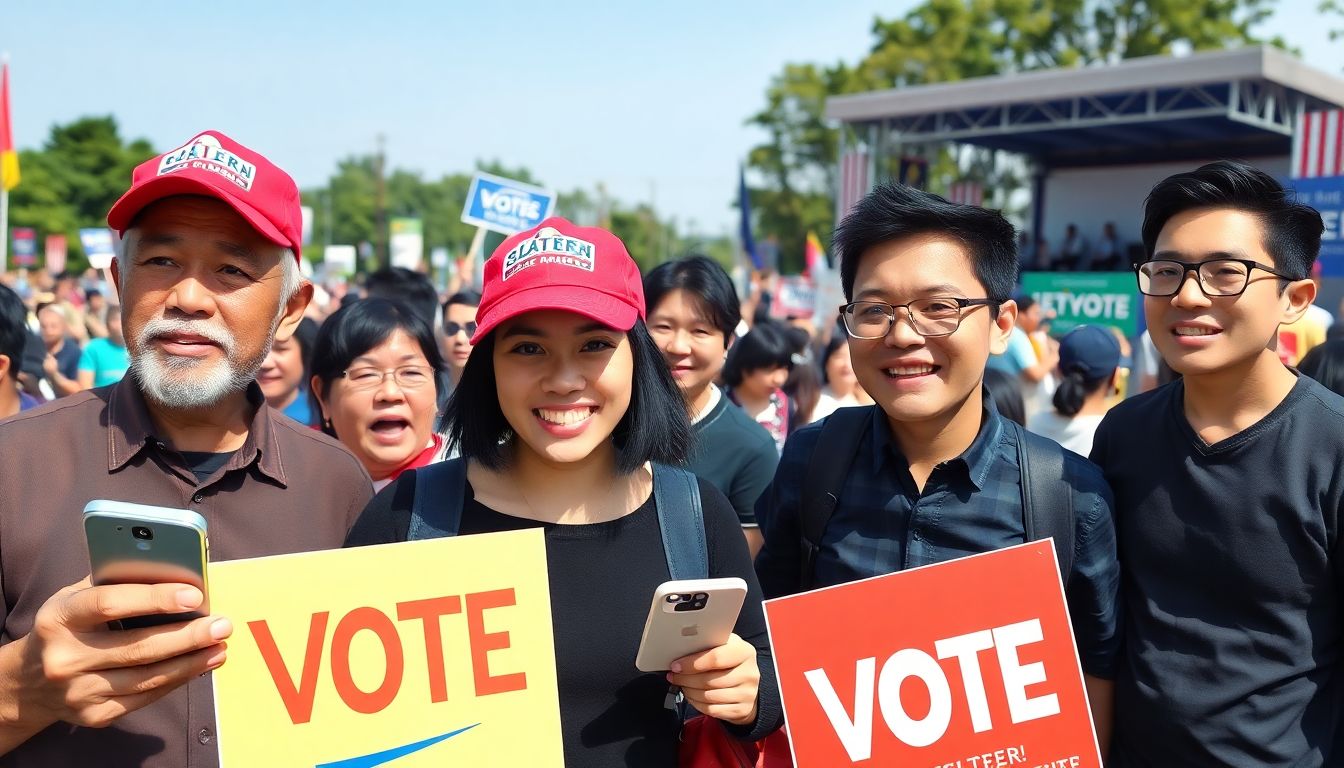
130,319,276,410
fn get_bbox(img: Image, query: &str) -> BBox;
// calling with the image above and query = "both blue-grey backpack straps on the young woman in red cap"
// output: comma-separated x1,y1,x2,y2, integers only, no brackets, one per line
406,457,710,580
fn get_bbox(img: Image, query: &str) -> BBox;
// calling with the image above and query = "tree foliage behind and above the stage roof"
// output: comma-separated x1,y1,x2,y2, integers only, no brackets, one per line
747,0,1284,270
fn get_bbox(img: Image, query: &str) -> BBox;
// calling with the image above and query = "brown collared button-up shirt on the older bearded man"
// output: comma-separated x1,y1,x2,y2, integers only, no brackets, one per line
0,377,372,768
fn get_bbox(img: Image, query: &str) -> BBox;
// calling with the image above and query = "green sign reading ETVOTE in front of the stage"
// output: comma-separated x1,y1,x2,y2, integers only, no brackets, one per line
1021,272,1142,338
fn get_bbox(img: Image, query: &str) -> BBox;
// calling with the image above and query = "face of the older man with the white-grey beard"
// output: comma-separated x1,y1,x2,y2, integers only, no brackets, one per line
113,196,312,409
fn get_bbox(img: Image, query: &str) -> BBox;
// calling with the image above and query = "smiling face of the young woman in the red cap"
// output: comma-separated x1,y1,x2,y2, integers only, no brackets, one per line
493,311,634,464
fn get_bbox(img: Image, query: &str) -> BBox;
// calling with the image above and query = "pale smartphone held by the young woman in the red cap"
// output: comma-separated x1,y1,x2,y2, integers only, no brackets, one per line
634,578,747,673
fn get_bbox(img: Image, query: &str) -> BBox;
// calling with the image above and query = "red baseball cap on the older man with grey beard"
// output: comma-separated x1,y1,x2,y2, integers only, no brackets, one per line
108,130,304,258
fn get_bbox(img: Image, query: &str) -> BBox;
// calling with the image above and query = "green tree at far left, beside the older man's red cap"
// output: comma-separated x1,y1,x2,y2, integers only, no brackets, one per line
9,116,155,269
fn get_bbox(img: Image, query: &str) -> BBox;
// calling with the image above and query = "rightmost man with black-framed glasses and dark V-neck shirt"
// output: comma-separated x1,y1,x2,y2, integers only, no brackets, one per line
1093,161,1344,767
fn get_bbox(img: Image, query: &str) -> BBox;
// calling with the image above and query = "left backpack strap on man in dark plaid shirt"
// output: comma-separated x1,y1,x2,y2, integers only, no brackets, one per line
798,405,876,592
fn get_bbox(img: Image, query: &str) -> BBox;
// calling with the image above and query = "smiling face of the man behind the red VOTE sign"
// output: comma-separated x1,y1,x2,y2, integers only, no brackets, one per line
849,234,1016,424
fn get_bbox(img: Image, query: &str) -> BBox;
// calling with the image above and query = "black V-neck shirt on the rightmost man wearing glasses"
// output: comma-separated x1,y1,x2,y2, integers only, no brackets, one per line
1091,377,1344,767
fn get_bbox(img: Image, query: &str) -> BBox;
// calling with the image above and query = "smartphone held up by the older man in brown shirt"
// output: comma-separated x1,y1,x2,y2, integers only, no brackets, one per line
83,499,210,629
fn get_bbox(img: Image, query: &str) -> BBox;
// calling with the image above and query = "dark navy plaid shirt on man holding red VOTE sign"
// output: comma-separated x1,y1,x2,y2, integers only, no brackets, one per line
757,398,1120,678
